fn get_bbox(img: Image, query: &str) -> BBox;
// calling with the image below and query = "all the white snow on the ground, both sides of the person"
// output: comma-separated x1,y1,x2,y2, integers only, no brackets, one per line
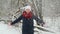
0,18,60,34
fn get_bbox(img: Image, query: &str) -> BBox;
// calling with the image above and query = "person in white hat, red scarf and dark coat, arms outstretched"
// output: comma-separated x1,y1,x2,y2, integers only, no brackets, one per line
10,6,44,34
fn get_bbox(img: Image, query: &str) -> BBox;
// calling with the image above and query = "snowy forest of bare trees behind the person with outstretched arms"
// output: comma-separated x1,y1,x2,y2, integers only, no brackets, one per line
0,0,60,34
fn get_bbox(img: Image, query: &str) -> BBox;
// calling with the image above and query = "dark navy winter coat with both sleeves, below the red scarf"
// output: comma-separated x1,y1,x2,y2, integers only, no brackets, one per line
11,11,43,34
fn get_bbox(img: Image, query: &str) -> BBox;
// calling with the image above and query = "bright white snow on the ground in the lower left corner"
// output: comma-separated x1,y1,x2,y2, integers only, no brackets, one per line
0,22,20,34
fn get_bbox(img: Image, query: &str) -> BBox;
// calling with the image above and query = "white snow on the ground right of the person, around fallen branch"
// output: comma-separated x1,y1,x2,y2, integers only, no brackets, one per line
34,17,60,34
